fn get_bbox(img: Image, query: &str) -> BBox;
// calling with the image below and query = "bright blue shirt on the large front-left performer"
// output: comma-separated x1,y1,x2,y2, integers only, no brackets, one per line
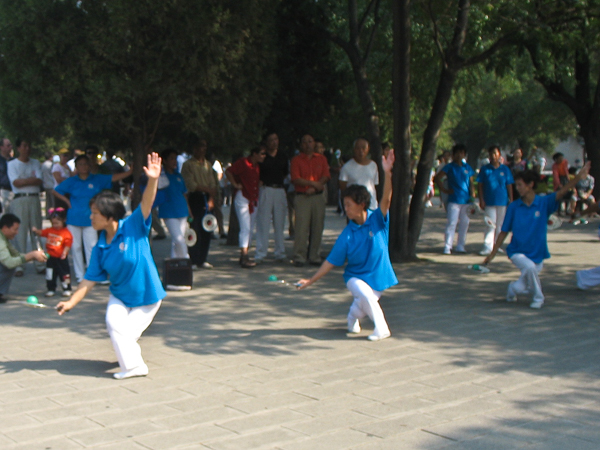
85,206,167,308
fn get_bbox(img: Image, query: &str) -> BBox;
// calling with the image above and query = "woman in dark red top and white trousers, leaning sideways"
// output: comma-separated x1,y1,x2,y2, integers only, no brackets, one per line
225,147,267,269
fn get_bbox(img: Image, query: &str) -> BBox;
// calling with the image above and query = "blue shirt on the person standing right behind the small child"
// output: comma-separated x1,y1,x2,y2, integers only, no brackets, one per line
54,174,112,227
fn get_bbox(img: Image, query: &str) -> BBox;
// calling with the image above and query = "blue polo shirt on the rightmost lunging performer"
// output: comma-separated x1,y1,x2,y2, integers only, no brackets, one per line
502,193,558,264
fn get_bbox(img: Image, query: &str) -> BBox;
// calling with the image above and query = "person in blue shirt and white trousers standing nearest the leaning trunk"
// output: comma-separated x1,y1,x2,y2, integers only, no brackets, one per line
434,144,475,255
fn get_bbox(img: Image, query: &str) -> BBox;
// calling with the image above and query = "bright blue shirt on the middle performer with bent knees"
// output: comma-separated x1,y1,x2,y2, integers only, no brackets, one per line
327,208,398,291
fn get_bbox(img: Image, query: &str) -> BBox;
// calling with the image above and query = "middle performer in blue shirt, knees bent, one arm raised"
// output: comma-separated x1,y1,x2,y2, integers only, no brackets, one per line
298,150,398,341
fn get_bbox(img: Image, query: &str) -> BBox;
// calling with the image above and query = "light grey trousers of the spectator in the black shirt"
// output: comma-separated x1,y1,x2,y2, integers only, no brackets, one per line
256,186,287,259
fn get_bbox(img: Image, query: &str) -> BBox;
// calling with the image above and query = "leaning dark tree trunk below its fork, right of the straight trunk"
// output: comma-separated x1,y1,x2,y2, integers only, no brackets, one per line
406,68,457,255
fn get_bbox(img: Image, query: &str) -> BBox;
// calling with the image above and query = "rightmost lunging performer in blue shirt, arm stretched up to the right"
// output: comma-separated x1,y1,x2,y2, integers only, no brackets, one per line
483,162,590,309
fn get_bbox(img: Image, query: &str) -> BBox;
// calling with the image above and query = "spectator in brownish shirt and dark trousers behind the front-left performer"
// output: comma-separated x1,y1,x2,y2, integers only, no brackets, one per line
181,139,219,269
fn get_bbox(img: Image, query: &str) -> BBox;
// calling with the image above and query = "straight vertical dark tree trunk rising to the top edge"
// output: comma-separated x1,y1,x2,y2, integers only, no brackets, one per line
390,0,415,262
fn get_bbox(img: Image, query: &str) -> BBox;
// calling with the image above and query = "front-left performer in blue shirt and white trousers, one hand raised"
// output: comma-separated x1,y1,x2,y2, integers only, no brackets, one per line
56,153,167,380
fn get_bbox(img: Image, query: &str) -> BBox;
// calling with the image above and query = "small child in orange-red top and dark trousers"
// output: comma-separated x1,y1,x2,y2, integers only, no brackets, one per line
31,208,73,297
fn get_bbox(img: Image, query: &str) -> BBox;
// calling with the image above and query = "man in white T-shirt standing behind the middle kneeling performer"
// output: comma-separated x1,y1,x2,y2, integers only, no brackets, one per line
339,138,379,209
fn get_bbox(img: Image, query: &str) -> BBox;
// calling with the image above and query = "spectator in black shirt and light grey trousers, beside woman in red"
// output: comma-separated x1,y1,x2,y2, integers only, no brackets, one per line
256,133,289,264
